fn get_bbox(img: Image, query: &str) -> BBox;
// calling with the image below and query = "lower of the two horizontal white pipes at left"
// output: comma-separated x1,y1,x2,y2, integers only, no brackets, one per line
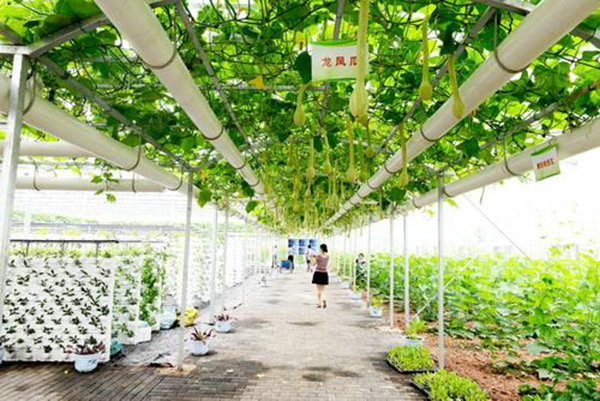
17,175,165,192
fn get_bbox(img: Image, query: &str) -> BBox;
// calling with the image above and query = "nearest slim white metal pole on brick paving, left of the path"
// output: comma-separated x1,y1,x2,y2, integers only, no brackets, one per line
177,173,194,370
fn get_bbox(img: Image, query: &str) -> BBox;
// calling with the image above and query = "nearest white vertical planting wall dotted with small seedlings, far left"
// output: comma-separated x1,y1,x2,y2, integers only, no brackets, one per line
1,255,115,362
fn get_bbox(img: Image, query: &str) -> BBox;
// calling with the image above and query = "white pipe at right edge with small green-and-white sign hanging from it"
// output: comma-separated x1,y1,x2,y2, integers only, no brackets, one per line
405,117,600,211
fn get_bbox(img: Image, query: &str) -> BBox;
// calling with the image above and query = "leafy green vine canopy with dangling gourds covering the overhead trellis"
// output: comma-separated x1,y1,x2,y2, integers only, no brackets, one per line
0,0,600,232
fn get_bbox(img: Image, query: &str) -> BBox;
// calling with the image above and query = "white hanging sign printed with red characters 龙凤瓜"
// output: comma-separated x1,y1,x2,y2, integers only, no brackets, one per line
311,40,368,82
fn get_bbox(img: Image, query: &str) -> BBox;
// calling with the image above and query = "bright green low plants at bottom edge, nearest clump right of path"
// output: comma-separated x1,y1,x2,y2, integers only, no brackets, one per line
413,370,488,401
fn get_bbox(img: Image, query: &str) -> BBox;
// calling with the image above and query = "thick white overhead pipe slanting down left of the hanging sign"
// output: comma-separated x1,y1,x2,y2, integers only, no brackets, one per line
96,0,264,195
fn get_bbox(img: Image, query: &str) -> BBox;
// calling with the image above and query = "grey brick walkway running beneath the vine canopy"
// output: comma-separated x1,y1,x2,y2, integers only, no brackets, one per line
0,269,424,401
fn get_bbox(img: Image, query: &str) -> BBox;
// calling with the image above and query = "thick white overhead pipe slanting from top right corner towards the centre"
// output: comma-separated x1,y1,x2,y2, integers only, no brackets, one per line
325,0,598,226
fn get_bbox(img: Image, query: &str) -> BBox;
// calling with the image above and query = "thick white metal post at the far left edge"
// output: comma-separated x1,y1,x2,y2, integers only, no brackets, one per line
0,55,29,331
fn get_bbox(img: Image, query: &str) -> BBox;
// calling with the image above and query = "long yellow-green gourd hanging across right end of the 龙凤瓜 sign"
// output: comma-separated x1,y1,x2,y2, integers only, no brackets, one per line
350,0,369,126
